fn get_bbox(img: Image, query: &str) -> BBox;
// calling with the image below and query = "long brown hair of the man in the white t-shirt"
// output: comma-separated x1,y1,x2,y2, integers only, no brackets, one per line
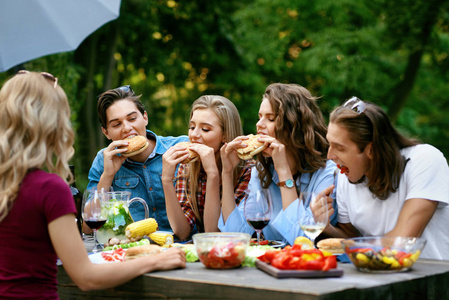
330,101,419,200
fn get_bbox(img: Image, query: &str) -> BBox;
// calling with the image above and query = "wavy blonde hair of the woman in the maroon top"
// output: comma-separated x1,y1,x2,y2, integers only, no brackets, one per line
0,72,75,222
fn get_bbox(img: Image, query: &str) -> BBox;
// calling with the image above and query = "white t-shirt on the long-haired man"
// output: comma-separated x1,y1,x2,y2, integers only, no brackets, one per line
337,144,449,260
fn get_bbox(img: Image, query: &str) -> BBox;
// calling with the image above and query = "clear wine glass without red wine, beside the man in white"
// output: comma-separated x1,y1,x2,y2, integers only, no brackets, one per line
299,193,329,245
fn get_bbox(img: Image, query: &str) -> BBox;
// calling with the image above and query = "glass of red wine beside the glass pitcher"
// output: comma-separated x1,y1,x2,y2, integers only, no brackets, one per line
82,189,108,253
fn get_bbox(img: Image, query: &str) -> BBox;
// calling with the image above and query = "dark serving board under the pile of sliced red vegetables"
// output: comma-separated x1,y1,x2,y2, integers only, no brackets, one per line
256,260,343,278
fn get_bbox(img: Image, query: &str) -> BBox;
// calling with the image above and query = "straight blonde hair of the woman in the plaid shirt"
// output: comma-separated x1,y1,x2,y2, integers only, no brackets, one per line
186,95,244,222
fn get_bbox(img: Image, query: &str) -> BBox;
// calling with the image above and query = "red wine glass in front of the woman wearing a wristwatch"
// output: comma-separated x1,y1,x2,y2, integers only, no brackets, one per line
243,189,273,245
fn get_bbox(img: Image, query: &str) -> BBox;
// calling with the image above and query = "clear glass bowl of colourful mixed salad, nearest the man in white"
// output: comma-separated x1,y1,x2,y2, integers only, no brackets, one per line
341,236,426,273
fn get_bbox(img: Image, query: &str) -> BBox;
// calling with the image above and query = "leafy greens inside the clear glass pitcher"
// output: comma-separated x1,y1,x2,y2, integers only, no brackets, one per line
102,199,133,235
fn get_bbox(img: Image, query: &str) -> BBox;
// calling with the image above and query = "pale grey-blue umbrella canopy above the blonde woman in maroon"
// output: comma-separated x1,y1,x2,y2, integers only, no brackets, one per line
0,0,121,72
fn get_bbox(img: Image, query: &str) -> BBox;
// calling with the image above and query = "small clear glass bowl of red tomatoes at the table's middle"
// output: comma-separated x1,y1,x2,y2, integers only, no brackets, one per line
192,232,251,269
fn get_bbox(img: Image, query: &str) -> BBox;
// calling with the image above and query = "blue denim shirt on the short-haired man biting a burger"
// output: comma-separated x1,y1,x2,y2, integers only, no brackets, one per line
87,130,189,231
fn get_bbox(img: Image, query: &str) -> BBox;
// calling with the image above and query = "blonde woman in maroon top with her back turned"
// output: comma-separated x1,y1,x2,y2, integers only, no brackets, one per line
0,71,185,299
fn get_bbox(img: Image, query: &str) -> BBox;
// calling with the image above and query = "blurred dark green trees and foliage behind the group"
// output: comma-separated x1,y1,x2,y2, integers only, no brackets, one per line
0,0,449,190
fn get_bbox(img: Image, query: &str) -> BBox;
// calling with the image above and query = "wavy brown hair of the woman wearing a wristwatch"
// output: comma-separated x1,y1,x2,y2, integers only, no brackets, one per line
257,83,329,188
